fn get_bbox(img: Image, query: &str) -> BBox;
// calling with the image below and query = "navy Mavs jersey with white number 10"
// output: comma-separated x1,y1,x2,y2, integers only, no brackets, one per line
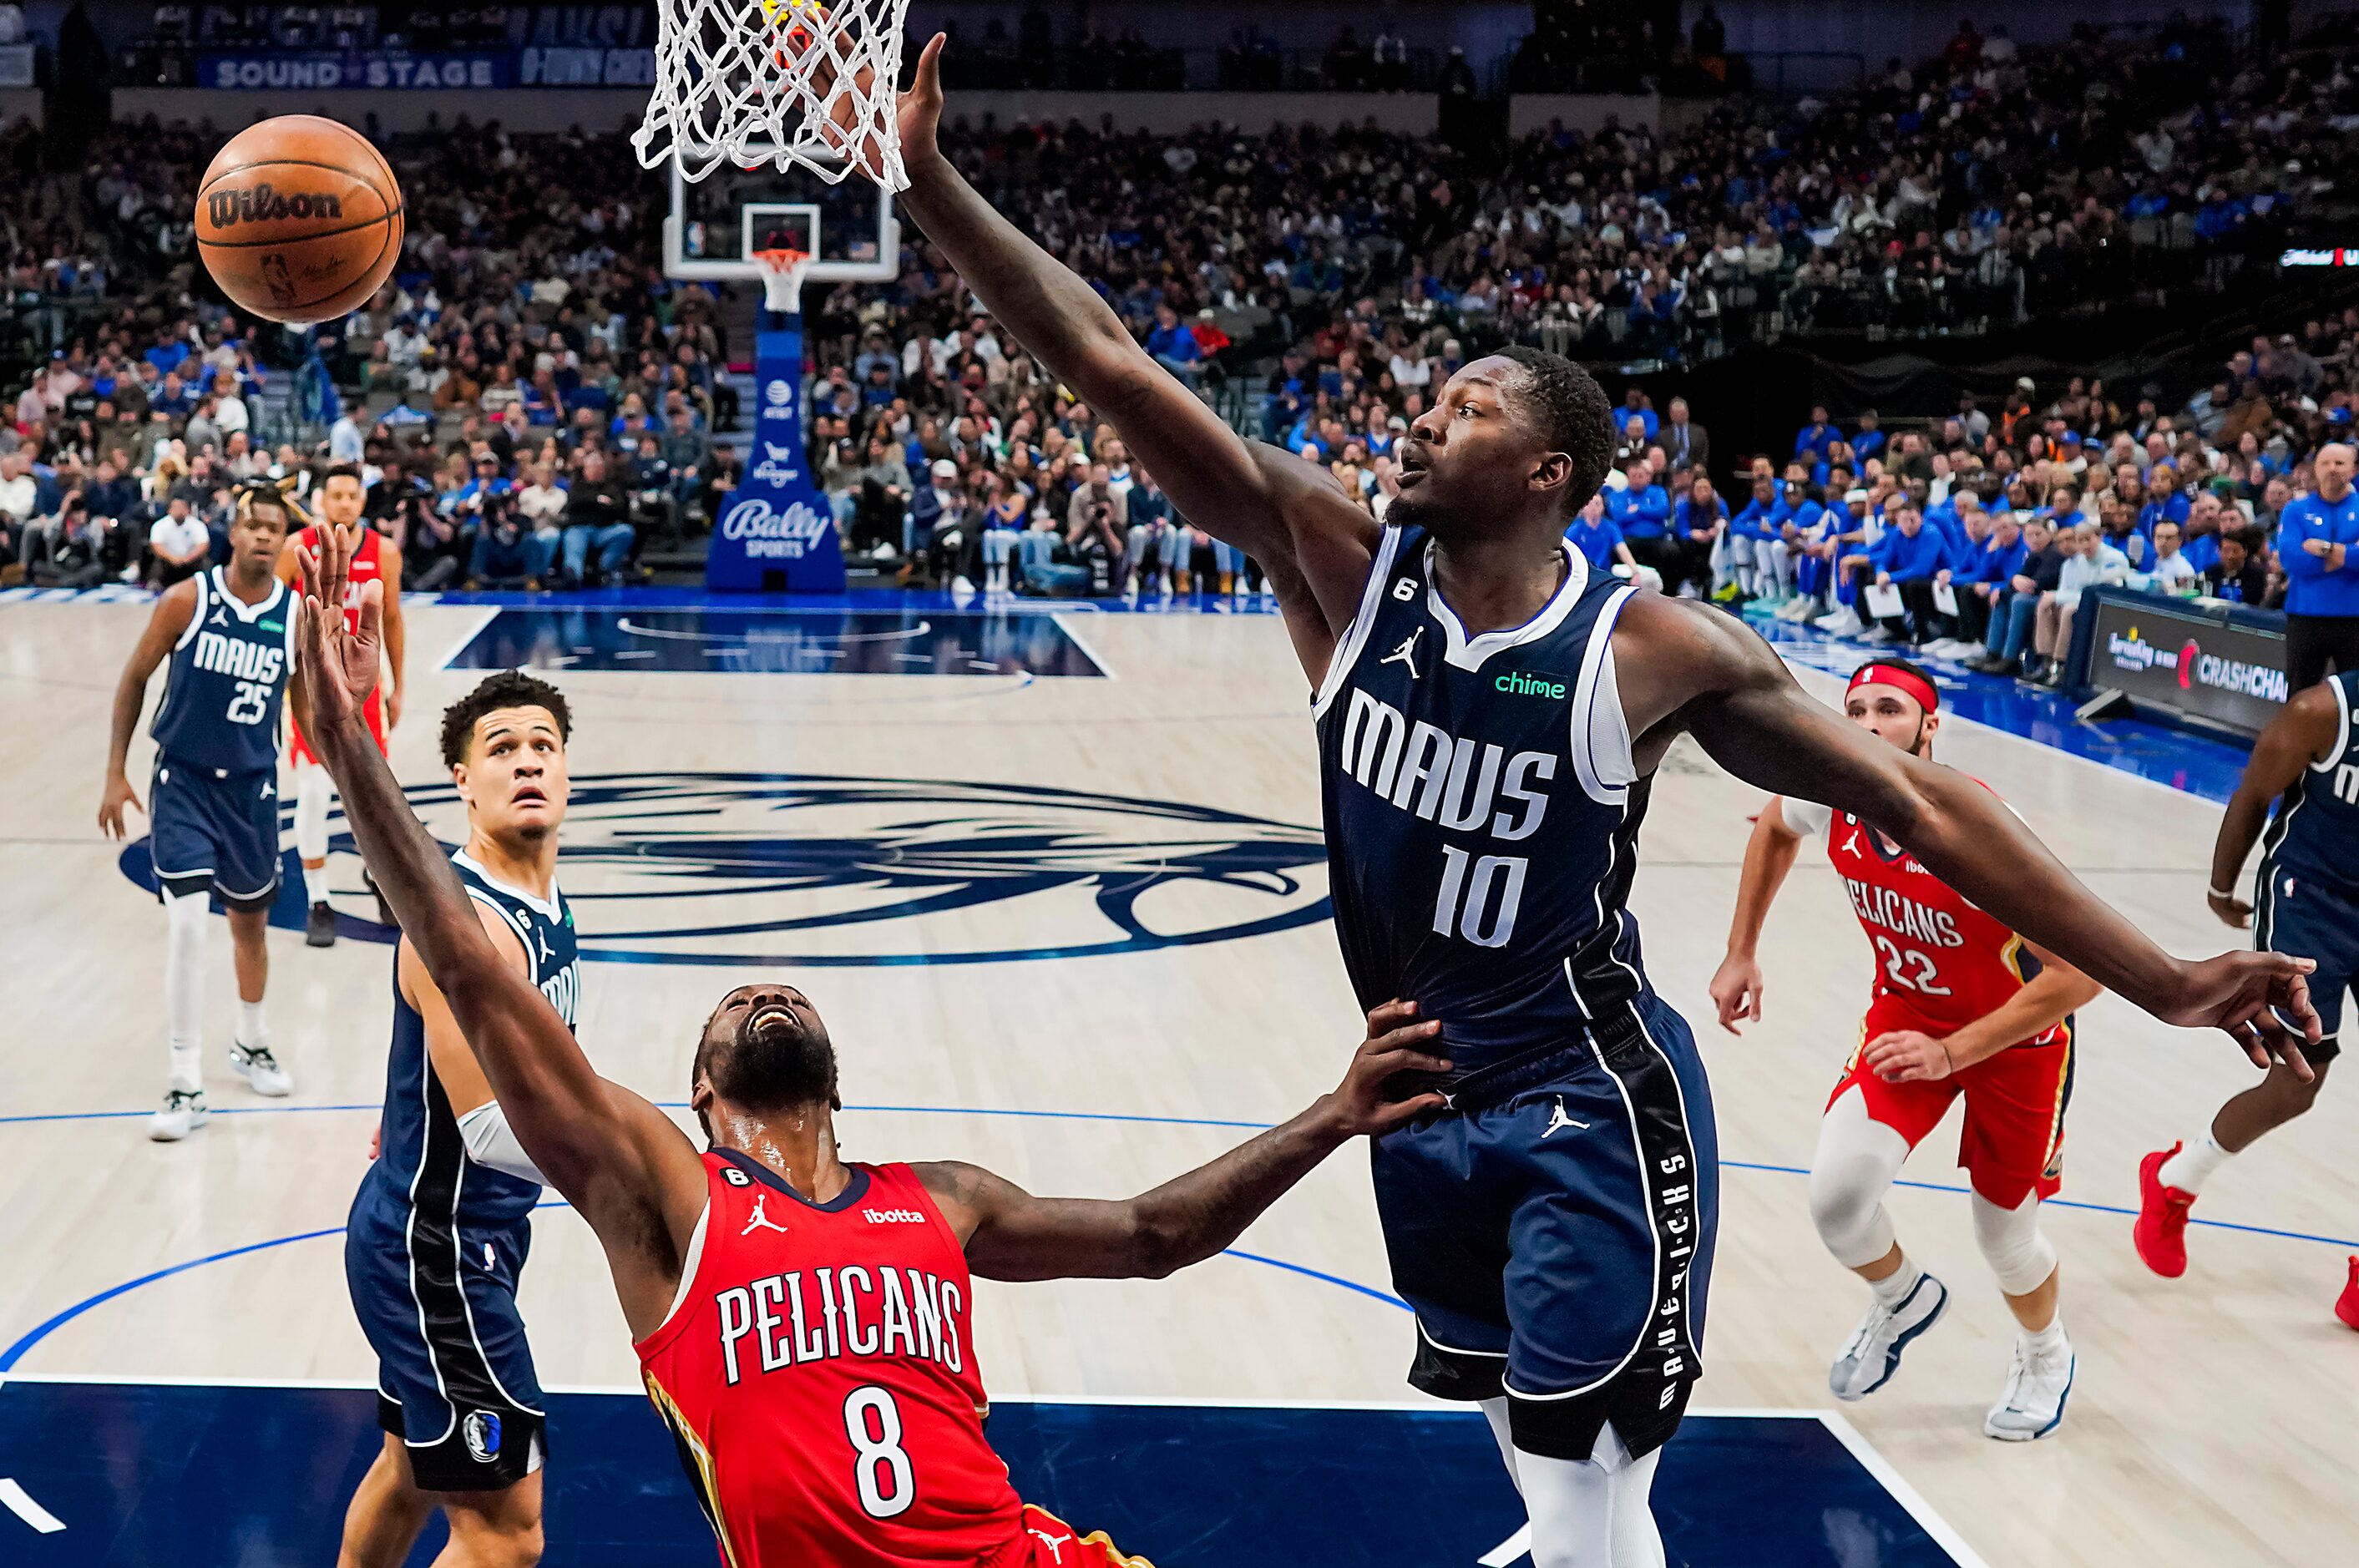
1312,529,1649,1078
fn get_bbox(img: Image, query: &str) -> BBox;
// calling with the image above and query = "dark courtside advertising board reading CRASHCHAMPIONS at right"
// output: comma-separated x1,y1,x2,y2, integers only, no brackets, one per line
2088,592,2293,736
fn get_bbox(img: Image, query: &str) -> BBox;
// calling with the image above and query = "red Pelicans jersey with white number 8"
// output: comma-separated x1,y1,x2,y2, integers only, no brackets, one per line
637,1148,1038,1568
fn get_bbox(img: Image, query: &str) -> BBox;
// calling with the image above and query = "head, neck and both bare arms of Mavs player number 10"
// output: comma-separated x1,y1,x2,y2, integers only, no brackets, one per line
858,35,2314,1075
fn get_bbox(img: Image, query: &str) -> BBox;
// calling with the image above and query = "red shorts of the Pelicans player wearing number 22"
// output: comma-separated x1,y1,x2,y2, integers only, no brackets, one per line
1826,998,2073,1210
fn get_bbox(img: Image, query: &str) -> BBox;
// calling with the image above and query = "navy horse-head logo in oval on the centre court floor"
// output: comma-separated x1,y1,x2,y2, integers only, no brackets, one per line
123,771,1330,967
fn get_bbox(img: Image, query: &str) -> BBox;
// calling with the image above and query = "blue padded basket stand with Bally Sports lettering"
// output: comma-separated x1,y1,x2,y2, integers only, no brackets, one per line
706,316,844,594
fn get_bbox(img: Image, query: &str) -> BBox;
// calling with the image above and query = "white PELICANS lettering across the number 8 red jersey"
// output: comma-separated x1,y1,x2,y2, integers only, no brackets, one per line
712,1264,967,1388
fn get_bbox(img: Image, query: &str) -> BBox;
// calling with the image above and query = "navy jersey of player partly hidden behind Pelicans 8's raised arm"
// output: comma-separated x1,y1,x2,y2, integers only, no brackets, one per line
371,851,580,1228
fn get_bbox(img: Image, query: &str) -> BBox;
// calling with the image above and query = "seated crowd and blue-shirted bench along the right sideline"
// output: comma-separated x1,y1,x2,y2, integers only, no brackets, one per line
1569,309,2359,686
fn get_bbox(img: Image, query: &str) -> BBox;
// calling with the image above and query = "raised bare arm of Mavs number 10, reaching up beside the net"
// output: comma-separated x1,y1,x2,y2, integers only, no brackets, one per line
858,35,1378,679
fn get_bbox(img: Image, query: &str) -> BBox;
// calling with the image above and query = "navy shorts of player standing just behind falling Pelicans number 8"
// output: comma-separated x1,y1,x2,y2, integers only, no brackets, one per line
344,1167,547,1493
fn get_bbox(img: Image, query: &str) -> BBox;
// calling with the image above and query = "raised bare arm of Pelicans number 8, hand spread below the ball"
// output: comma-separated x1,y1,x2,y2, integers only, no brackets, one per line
297,529,706,1333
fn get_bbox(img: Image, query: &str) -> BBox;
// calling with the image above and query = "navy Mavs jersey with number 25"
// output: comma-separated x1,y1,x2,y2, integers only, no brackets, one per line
151,566,302,773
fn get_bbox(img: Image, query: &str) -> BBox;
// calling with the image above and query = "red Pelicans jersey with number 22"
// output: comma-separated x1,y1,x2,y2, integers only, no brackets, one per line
1781,799,2067,1044
